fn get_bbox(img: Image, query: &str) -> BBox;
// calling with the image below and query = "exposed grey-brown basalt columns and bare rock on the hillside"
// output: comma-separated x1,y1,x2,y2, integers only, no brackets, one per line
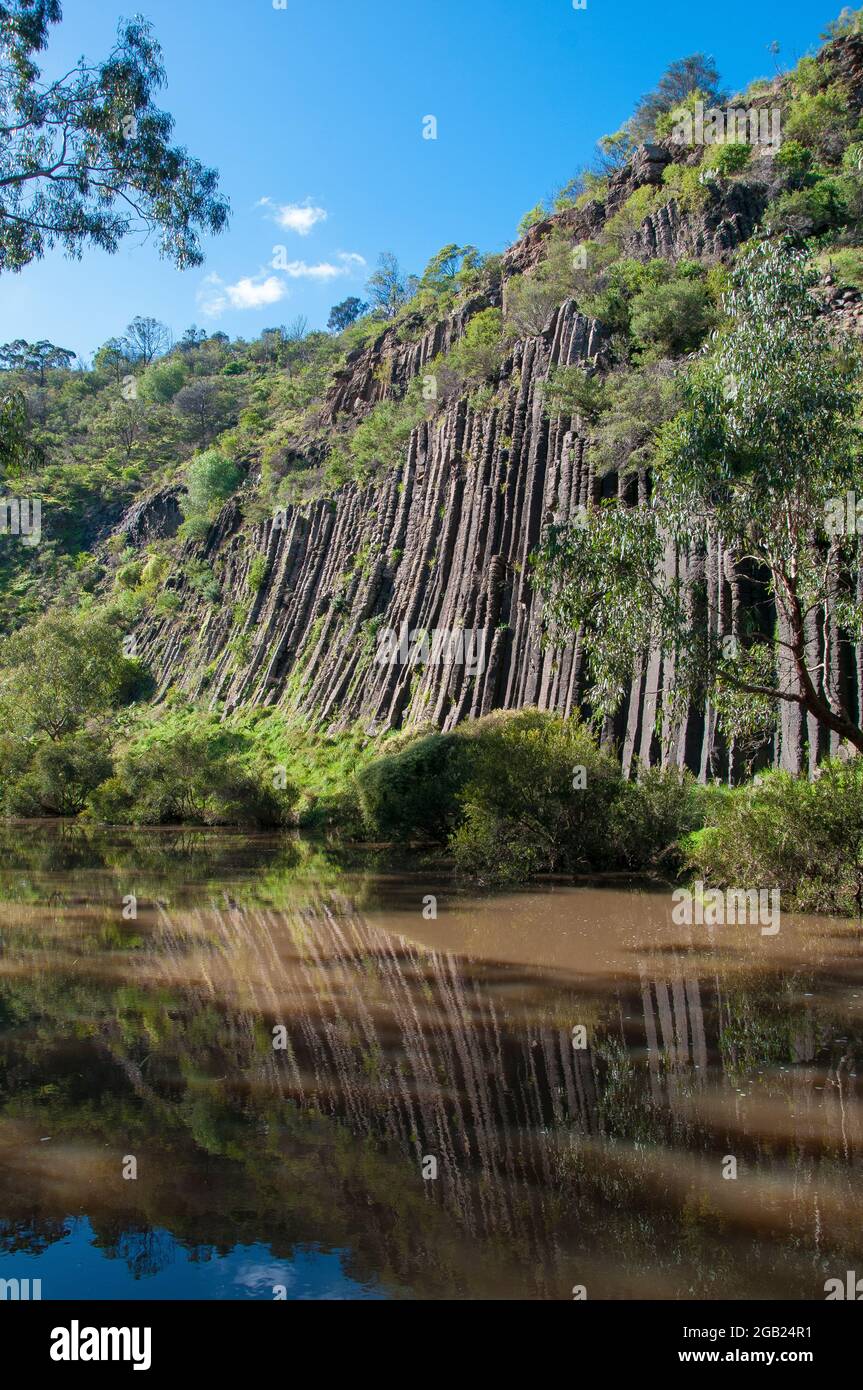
132,65,863,777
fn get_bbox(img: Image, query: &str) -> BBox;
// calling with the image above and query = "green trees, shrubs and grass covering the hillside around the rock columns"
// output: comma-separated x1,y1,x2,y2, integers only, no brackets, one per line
0,11,863,908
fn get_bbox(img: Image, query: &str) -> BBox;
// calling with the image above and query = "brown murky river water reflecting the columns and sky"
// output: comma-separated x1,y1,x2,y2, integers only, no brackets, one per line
0,824,863,1300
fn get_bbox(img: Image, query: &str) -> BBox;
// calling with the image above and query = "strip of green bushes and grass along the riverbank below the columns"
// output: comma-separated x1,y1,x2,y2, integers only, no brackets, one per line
3,703,863,916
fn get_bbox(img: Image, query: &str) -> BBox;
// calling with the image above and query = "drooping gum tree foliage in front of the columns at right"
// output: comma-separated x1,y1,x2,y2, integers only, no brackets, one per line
535,242,863,751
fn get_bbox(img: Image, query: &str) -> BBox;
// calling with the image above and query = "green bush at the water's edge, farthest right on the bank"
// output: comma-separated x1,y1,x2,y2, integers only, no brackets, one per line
687,758,863,913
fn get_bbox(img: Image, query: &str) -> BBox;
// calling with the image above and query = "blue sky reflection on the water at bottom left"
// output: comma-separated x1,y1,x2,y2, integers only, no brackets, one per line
0,1218,388,1301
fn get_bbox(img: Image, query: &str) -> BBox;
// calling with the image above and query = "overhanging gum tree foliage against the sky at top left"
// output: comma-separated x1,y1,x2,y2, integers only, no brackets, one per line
0,0,228,271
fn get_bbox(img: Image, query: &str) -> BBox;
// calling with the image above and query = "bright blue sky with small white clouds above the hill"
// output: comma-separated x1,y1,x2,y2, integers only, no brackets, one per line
0,0,841,354
